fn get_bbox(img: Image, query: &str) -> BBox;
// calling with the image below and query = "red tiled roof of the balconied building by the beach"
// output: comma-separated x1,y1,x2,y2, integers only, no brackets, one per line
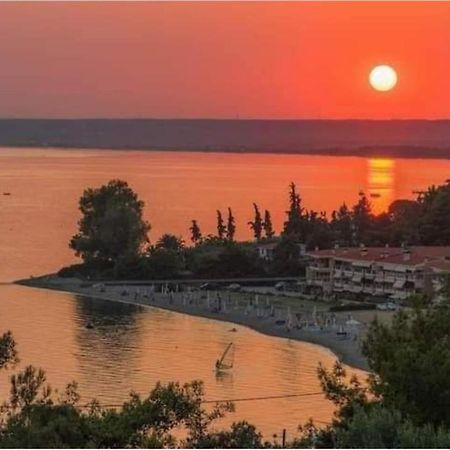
307,246,450,266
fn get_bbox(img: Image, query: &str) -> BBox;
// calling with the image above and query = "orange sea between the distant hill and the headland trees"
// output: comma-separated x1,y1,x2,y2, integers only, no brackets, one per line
0,149,450,281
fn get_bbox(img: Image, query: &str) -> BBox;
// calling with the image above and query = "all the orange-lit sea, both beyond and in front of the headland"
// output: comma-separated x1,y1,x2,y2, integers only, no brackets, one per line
0,149,450,436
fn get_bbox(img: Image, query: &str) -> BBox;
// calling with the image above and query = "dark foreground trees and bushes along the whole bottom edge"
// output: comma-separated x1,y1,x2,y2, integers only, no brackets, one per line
0,289,450,448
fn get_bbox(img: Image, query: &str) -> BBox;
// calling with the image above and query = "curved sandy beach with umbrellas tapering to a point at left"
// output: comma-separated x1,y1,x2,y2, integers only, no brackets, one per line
13,276,392,370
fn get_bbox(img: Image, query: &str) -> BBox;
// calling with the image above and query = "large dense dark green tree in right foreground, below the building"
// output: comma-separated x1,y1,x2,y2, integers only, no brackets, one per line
363,305,450,428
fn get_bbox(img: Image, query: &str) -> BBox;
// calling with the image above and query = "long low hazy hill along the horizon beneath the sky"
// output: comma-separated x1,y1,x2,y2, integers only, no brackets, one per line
0,119,450,158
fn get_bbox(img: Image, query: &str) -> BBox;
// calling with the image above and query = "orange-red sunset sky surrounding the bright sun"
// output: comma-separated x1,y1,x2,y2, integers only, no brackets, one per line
0,2,450,118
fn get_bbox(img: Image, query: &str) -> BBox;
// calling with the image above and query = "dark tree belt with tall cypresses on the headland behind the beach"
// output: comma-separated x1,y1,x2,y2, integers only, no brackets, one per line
59,180,450,280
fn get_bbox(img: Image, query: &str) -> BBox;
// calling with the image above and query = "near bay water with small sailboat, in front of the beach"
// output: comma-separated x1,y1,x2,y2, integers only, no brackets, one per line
0,285,352,437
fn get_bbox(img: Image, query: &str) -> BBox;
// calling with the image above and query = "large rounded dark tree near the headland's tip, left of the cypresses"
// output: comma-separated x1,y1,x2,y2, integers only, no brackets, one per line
69,180,150,264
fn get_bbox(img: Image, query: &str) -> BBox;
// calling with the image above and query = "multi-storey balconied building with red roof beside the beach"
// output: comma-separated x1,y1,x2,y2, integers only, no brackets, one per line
306,247,450,300
